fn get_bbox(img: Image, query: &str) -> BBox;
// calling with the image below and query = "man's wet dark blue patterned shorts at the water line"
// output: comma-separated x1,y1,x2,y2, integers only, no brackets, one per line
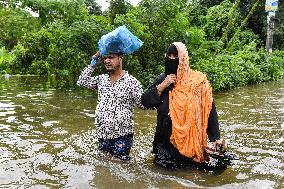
99,134,133,160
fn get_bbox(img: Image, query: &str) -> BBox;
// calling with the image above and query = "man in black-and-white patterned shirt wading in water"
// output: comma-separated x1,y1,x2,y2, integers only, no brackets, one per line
77,25,143,160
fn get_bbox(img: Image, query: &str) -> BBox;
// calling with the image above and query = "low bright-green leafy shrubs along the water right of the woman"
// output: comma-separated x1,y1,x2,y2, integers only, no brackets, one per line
195,43,284,91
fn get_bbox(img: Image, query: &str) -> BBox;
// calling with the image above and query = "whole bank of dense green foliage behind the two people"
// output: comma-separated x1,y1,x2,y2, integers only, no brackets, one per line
0,0,284,91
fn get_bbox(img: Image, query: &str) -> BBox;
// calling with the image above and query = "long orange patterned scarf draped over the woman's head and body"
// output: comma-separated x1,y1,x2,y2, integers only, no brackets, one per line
169,42,213,162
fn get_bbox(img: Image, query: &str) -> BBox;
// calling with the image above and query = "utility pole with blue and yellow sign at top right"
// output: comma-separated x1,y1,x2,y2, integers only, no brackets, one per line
265,0,278,53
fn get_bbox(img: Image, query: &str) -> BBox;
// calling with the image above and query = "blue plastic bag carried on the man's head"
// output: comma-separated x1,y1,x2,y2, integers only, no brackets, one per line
98,25,143,56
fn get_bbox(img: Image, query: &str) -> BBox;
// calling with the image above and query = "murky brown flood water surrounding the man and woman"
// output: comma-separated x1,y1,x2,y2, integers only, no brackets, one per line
0,76,284,189
